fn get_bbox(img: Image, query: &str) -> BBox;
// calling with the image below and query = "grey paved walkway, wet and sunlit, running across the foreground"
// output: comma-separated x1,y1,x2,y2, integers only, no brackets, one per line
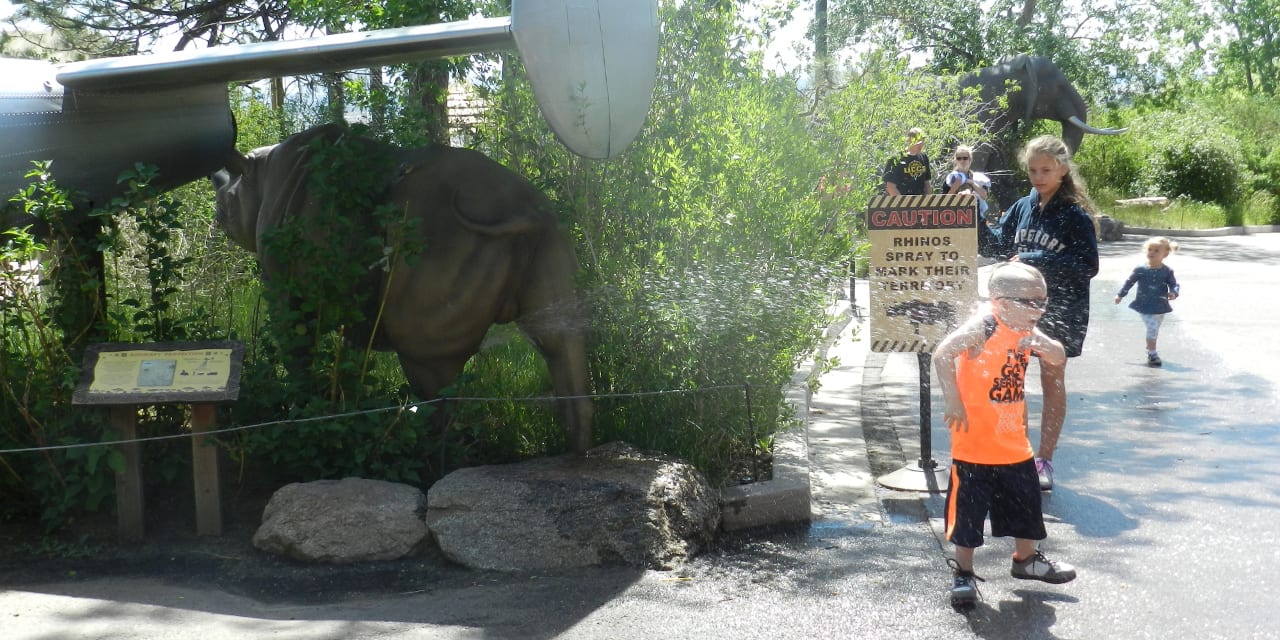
0,233,1280,640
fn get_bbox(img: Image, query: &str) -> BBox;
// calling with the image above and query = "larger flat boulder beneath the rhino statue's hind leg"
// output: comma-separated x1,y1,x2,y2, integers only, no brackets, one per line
426,444,721,571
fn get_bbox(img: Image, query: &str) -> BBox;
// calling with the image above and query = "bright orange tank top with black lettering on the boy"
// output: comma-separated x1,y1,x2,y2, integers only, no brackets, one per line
951,316,1034,465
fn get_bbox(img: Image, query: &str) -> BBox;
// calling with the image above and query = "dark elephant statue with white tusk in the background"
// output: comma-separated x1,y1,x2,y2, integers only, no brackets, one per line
959,54,1128,205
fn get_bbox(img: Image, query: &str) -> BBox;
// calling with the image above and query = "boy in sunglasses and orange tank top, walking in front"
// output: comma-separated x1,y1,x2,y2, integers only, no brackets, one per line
933,262,1075,609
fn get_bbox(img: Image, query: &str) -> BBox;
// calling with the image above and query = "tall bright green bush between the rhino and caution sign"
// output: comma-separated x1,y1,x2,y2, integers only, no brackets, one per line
455,3,844,480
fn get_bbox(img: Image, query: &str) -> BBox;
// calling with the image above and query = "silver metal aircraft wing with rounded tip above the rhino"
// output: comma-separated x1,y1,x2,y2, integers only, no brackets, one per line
0,0,658,204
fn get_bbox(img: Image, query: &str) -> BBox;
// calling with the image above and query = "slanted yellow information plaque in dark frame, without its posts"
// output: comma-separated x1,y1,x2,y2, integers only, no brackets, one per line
72,340,244,404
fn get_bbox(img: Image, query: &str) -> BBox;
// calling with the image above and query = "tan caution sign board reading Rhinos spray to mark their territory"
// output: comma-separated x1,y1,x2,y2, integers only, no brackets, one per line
867,193,978,352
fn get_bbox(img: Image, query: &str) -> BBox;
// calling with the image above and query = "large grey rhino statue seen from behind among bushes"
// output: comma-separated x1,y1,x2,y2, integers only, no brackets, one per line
211,124,593,453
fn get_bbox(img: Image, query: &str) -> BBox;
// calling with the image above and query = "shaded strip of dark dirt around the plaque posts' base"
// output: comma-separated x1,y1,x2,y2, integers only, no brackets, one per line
0,481,484,603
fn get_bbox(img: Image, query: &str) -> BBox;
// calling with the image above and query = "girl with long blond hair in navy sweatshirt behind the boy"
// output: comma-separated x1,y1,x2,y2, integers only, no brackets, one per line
978,136,1098,490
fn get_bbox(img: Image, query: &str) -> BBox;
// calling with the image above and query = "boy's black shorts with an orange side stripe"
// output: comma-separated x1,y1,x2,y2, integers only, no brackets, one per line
946,460,1046,548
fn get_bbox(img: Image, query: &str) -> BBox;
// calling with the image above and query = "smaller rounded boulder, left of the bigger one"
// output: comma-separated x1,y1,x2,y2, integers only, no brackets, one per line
253,477,428,564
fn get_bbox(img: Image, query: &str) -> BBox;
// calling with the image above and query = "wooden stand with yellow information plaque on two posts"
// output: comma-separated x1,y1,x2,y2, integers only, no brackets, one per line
72,342,244,543
